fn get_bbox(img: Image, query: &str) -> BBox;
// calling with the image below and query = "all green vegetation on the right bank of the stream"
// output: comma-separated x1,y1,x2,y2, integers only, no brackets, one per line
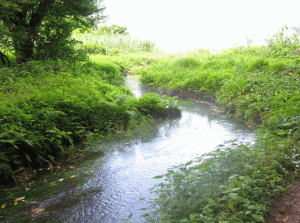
139,27,300,222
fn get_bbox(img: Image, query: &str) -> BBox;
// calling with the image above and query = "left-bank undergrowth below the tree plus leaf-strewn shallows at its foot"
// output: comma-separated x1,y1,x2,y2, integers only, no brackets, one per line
0,30,180,222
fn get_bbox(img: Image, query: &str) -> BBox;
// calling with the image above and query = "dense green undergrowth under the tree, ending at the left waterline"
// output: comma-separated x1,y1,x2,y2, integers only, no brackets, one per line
0,57,180,185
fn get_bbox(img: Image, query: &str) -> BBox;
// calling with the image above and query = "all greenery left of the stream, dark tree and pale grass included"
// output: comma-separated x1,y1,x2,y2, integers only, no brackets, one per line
0,0,180,222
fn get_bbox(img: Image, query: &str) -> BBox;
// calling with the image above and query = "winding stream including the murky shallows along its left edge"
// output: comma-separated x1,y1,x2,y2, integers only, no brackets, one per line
0,77,255,223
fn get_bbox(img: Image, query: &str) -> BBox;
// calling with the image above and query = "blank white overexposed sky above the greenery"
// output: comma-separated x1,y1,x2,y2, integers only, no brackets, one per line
104,0,300,52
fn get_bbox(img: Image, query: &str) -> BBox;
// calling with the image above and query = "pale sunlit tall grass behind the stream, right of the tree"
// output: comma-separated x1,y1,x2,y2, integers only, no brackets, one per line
73,30,166,74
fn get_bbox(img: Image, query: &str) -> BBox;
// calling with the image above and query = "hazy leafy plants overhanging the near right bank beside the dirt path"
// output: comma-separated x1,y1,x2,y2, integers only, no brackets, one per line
145,142,291,222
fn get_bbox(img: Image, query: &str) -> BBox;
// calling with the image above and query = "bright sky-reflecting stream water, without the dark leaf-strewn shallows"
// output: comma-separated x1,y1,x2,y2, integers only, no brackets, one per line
42,78,255,223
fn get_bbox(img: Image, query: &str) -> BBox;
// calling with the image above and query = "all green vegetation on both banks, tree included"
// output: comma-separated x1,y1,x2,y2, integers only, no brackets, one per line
0,3,300,222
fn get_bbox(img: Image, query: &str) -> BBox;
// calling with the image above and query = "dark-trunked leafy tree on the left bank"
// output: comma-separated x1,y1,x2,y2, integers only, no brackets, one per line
0,0,105,63
